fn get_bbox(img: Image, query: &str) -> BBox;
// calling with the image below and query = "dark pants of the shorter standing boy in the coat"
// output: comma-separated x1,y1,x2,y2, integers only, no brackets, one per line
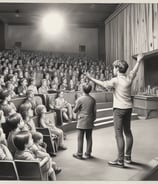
77,129,92,156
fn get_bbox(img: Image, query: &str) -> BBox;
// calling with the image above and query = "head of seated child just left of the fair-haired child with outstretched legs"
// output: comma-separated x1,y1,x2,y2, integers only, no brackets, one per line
19,102,33,120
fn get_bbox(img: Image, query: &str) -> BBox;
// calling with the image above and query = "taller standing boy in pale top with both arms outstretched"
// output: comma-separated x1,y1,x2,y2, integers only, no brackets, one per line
87,54,143,167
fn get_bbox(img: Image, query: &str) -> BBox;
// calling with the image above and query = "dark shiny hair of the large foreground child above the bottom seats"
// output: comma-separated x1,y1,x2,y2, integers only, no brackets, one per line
13,131,31,151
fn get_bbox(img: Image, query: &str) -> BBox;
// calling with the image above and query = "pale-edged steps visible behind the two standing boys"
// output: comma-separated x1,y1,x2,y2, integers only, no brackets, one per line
62,102,138,132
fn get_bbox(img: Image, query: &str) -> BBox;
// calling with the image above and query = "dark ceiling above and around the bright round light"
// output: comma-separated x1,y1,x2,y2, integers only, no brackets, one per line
0,3,119,27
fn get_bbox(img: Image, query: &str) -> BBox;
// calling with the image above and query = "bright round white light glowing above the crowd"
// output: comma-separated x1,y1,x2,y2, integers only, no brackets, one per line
42,12,65,35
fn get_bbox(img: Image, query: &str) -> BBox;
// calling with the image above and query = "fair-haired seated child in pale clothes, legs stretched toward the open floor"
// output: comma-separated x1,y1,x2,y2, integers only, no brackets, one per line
36,105,67,150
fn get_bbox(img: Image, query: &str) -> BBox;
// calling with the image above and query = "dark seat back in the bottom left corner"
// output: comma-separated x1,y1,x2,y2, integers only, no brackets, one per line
0,160,19,180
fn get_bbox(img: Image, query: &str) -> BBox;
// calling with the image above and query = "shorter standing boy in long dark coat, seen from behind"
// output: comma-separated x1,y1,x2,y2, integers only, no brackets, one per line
73,84,96,159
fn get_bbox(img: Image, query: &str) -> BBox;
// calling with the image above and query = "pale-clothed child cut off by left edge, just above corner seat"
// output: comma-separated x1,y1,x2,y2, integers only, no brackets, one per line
0,128,13,160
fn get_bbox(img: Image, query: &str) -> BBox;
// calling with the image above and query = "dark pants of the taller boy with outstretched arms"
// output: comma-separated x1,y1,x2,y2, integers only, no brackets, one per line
113,108,133,160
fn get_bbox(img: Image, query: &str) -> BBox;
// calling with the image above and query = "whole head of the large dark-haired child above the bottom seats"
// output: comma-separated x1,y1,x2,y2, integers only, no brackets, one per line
13,131,33,151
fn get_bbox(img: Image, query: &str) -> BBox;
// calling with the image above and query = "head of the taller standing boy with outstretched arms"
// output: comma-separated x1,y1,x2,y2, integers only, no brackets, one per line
113,60,128,76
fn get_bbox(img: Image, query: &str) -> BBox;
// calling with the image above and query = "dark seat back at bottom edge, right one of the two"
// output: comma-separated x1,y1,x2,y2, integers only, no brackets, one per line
15,160,42,181
